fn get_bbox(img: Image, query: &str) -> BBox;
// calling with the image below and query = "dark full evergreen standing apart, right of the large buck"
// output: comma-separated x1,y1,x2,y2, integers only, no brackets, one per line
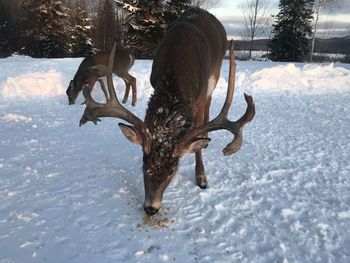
269,0,314,61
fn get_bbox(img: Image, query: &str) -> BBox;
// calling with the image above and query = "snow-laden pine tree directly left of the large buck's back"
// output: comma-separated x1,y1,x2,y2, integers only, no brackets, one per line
116,0,167,58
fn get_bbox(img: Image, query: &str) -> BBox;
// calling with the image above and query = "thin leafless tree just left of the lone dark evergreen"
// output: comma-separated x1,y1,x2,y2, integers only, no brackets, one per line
241,0,269,58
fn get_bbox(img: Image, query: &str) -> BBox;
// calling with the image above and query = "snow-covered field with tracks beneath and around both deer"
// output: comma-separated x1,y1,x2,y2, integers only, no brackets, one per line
0,57,350,263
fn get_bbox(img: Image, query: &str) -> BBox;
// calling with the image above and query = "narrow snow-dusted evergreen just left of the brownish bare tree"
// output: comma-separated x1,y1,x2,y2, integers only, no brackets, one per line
70,0,94,57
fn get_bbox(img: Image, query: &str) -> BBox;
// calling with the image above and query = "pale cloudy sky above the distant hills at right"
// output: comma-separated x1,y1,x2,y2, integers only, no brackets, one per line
209,0,350,38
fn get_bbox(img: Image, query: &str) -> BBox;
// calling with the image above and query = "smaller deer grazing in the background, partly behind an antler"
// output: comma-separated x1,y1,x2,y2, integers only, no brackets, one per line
66,46,137,106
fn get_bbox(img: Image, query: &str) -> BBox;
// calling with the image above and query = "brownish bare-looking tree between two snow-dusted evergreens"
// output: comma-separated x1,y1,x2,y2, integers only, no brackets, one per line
93,0,123,51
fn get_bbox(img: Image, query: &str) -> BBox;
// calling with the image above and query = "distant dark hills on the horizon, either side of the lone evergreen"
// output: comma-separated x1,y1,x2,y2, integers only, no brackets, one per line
235,36,350,54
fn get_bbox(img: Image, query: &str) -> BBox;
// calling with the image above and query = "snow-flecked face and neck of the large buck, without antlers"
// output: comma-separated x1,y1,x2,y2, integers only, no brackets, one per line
143,93,193,214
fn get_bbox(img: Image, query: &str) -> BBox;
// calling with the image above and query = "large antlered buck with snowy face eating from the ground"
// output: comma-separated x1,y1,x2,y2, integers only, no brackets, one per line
80,7,255,216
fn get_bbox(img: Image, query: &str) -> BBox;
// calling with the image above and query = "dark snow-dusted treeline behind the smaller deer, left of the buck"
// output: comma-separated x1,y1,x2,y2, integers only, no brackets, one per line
0,0,192,58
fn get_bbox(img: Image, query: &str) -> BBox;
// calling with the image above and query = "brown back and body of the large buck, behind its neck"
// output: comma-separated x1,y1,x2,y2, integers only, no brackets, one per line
151,8,227,101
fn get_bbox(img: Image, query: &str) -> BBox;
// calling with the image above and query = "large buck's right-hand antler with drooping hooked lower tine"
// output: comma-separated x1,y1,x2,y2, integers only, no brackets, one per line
178,40,255,156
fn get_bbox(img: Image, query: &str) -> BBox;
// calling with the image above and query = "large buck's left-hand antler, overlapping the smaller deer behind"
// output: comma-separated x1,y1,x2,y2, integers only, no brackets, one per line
79,43,145,134
